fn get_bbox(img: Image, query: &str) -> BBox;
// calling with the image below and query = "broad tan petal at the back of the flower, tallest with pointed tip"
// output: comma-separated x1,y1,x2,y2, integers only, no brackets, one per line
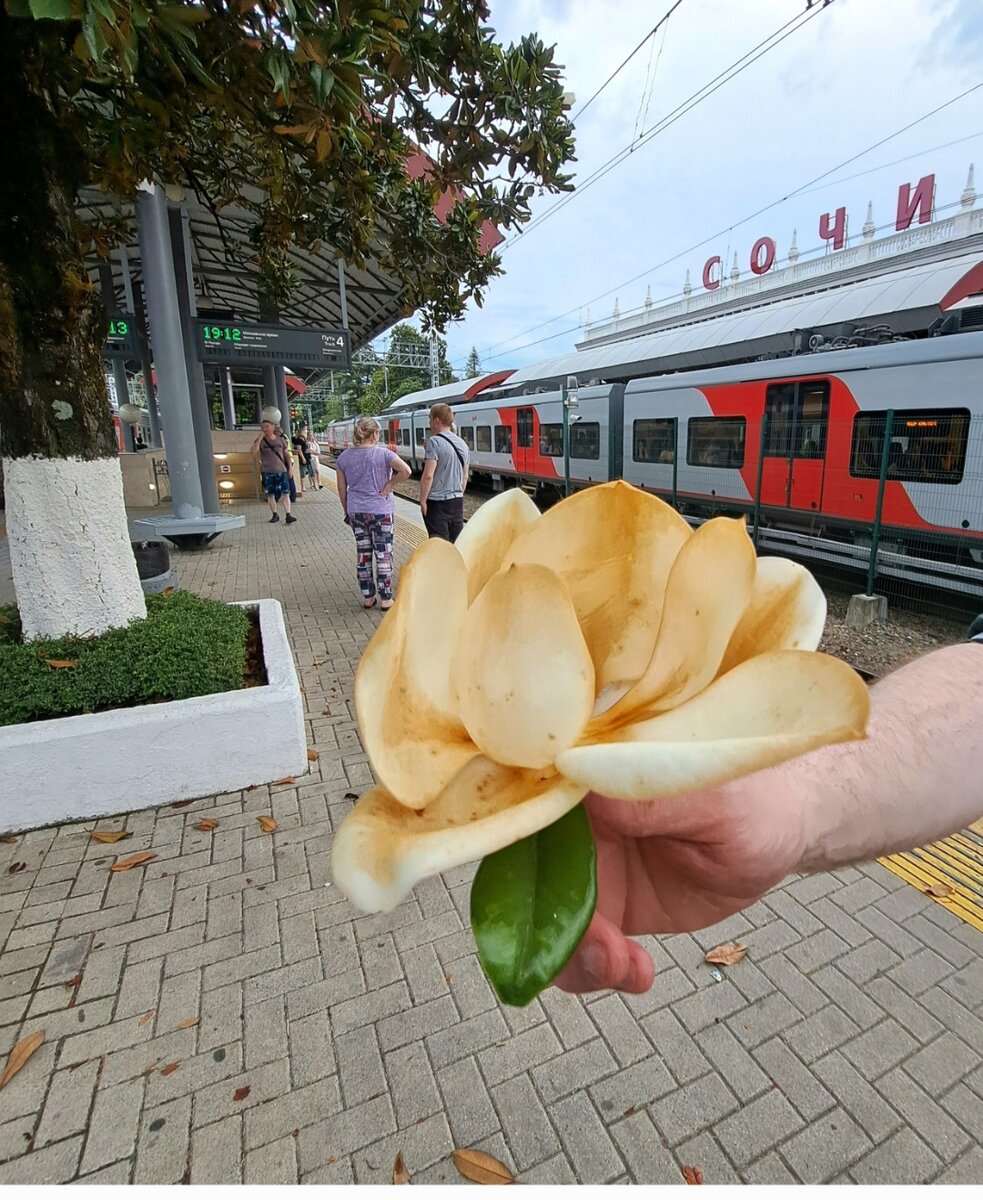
505,481,691,691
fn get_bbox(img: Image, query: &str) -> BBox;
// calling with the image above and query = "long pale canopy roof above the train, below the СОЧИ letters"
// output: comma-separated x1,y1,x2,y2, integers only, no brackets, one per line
509,251,983,389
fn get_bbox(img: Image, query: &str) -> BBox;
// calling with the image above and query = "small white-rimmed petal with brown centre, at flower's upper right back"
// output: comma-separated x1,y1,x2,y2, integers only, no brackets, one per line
718,558,826,674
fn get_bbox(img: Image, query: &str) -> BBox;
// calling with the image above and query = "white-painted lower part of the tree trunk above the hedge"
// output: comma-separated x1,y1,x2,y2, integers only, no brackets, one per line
4,457,146,641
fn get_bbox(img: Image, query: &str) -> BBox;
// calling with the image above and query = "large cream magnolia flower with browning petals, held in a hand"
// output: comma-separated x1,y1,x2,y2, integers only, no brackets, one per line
332,482,869,912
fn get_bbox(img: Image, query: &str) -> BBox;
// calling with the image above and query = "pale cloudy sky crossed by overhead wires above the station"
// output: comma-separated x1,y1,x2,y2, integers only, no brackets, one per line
398,0,983,374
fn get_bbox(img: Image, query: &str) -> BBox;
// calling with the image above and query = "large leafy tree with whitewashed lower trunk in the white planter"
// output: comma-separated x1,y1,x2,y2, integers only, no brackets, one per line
0,0,573,637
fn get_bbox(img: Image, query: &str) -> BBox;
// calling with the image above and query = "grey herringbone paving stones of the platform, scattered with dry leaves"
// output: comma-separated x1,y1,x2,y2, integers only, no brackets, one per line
0,490,983,1183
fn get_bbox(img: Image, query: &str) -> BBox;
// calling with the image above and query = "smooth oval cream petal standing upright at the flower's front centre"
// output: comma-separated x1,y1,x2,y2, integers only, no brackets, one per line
452,564,594,768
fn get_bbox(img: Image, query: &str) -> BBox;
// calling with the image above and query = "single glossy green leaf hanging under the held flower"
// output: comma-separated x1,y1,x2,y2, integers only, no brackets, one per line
470,804,598,1007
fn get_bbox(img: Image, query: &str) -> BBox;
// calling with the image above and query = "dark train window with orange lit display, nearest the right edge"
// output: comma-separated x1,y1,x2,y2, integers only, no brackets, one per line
850,408,970,484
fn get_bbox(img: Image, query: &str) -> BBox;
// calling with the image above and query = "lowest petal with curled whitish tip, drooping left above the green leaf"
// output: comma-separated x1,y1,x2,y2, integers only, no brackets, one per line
331,758,587,912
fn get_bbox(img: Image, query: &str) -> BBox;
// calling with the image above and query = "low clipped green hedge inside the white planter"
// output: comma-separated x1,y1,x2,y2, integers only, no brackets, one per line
0,592,250,725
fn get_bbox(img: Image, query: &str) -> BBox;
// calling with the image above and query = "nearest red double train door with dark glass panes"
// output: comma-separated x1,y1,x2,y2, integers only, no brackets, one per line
761,379,829,511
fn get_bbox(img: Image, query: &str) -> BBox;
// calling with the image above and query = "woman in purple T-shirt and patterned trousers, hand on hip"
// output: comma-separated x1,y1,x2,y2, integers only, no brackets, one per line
335,416,410,608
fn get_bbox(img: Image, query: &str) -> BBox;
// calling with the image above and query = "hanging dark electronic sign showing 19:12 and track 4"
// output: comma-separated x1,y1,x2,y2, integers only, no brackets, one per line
196,320,352,371
